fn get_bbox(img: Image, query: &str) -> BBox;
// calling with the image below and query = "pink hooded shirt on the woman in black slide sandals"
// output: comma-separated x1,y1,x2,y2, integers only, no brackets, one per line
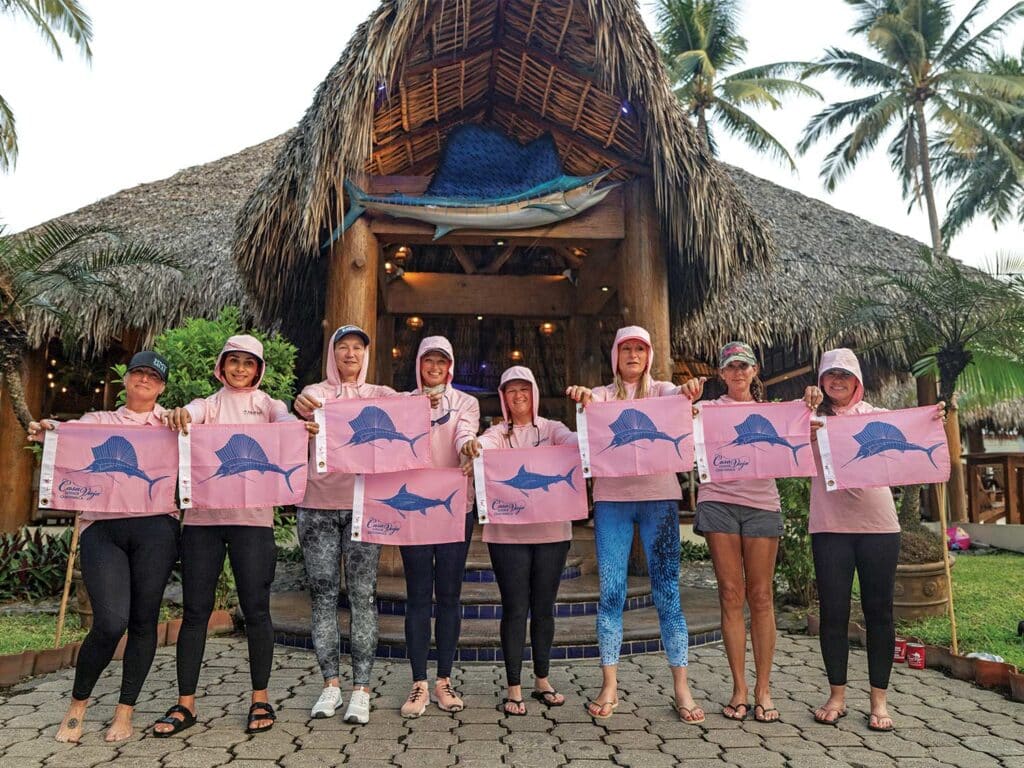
185,334,296,527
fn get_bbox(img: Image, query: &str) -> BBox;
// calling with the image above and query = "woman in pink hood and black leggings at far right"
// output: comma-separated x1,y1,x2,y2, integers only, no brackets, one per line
807,349,945,731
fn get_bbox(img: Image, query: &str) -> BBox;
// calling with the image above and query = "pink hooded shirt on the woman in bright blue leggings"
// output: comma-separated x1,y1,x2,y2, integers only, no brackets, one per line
591,326,683,502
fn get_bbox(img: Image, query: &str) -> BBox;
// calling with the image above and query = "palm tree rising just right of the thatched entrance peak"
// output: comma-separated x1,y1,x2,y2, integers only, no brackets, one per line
656,0,821,170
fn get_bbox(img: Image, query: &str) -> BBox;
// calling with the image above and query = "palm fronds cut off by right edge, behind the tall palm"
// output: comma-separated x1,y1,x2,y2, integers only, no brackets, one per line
932,48,1024,243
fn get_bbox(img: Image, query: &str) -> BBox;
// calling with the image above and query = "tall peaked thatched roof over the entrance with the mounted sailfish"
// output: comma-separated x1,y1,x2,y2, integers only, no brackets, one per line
234,0,771,346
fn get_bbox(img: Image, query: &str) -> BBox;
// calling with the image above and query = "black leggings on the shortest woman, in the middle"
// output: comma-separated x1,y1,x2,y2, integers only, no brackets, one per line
487,542,569,685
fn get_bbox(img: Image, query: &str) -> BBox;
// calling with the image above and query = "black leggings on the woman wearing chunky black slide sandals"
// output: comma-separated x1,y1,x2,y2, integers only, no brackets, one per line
177,525,278,696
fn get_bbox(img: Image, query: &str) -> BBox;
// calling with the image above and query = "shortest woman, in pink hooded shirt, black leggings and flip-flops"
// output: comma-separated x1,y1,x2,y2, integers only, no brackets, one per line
463,366,577,716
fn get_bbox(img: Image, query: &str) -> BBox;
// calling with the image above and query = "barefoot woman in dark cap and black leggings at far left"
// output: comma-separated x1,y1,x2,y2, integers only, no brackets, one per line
29,351,178,743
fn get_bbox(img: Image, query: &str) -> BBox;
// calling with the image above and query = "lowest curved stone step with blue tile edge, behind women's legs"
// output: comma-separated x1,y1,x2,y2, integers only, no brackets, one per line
270,587,722,662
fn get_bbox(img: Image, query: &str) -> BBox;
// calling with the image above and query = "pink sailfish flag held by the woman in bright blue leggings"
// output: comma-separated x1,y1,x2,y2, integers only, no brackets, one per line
577,395,693,477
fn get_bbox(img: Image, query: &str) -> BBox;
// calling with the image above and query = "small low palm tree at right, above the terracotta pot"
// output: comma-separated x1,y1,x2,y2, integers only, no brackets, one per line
837,251,1024,520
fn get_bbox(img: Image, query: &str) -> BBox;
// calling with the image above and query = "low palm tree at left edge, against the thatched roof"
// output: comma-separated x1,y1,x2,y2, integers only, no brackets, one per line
0,223,181,429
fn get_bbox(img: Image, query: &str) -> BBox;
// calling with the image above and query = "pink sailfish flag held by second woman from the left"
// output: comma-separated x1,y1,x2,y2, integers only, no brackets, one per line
178,421,309,509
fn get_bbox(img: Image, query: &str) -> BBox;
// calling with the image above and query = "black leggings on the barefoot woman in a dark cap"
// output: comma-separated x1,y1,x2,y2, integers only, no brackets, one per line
72,515,179,707
